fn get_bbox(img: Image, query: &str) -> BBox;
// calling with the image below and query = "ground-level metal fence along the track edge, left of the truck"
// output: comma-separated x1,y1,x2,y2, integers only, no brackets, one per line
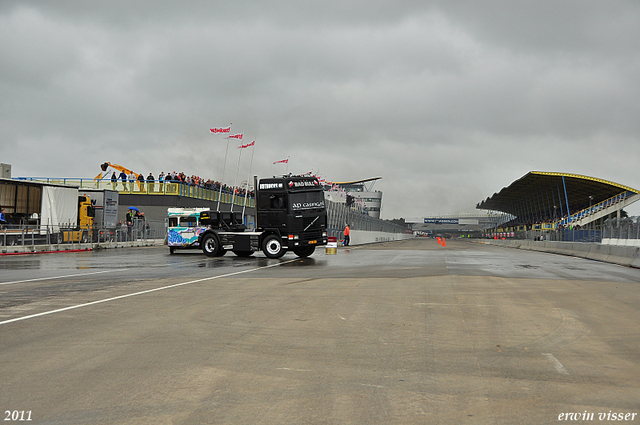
0,219,166,250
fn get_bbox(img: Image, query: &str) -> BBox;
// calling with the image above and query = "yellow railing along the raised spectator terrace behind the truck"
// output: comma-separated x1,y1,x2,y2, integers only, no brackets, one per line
15,177,255,208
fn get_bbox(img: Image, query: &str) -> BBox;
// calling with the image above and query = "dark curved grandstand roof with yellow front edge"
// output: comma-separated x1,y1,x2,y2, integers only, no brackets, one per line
476,171,640,216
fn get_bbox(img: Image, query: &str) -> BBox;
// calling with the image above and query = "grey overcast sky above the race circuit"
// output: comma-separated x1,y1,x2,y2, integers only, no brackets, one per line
0,0,640,218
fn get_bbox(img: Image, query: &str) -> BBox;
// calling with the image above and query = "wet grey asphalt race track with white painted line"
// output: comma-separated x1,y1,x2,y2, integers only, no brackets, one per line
0,238,640,425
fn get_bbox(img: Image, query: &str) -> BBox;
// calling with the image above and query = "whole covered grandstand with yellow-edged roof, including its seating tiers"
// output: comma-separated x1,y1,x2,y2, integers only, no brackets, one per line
476,171,640,231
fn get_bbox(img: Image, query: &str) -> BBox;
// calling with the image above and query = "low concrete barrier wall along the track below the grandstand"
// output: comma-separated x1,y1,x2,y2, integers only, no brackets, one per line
482,239,640,268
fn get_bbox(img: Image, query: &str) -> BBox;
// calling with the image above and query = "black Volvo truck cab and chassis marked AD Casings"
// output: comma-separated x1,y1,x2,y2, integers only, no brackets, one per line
198,176,327,258
